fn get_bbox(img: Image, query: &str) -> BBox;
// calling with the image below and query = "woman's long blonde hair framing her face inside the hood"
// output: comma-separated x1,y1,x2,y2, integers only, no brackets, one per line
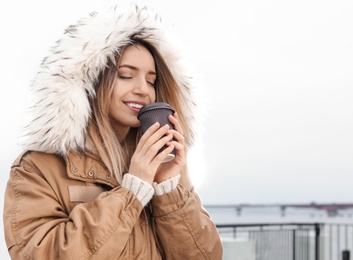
88,39,191,182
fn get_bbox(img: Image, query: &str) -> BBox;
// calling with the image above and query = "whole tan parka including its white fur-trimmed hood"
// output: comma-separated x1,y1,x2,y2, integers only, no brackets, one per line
3,3,222,260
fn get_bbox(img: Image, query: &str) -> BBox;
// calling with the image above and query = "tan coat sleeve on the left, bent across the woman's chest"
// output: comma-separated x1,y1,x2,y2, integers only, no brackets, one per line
3,155,143,259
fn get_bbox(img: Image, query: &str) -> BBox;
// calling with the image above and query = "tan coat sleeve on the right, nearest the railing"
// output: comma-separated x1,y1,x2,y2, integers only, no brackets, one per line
152,185,223,260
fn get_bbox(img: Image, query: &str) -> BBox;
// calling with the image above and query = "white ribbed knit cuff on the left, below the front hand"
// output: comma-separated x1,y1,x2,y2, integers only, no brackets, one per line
121,173,154,206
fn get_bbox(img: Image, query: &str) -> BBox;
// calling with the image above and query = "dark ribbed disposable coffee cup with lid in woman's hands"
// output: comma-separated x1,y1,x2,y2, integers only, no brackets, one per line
137,102,175,163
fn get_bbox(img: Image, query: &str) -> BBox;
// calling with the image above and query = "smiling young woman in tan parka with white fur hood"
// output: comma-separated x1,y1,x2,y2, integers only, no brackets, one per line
4,4,222,260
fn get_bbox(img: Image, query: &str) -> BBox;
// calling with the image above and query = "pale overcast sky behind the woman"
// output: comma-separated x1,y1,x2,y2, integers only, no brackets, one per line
0,0,353,259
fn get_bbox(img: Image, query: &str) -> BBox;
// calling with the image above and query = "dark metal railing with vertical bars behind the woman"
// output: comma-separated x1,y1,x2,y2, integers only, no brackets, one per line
217,223,353,260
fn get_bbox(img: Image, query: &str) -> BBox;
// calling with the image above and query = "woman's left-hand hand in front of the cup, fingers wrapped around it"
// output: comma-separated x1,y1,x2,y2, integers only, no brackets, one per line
129,123,174,184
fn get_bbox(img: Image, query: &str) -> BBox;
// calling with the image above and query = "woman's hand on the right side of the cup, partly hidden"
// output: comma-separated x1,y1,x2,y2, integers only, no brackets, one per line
154,113,186,183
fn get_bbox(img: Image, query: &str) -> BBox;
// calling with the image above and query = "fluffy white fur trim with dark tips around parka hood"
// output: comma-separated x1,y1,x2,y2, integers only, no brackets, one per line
21,6,195,155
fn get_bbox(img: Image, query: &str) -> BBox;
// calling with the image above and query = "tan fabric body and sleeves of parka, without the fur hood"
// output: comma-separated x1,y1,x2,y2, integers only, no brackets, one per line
4,149,222,260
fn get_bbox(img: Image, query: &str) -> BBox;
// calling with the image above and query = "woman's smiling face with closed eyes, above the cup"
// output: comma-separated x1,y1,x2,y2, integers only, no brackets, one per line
109,44,156,137
